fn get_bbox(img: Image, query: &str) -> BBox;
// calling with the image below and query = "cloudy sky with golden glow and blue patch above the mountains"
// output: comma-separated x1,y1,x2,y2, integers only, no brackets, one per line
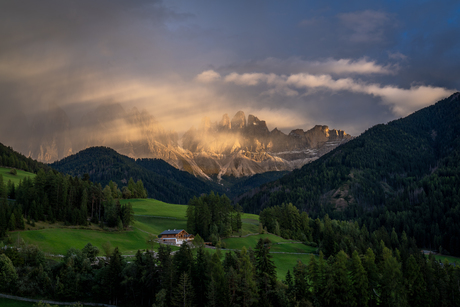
0,0,460,137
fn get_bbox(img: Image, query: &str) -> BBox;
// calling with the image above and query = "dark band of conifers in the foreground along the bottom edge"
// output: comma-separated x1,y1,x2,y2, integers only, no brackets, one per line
0,239,460,307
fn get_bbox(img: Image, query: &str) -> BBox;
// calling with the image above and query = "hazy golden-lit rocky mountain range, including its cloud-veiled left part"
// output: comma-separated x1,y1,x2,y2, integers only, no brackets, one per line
10,103,351,180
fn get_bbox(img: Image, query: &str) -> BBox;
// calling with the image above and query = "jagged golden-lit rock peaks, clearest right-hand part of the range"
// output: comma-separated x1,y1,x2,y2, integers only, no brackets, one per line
178,111,351,178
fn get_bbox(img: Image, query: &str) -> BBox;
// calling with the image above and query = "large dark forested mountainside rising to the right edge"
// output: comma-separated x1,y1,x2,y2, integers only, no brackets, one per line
240,93,460,255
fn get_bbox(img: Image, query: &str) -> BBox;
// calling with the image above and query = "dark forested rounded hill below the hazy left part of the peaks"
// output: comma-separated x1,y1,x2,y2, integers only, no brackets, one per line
50,147,221,204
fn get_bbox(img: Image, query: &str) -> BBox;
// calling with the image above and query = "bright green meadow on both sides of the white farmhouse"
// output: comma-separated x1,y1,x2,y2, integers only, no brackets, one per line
12,199,316,280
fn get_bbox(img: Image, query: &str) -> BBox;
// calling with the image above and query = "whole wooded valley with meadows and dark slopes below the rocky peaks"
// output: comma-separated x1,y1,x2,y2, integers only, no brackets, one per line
0,93,460,305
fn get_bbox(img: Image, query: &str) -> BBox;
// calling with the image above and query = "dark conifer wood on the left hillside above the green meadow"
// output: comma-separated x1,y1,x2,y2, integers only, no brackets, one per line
0,169,142,237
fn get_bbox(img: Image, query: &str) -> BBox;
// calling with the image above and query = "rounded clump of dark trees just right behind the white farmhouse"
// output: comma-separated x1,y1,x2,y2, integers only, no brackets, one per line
186,192,242,245
